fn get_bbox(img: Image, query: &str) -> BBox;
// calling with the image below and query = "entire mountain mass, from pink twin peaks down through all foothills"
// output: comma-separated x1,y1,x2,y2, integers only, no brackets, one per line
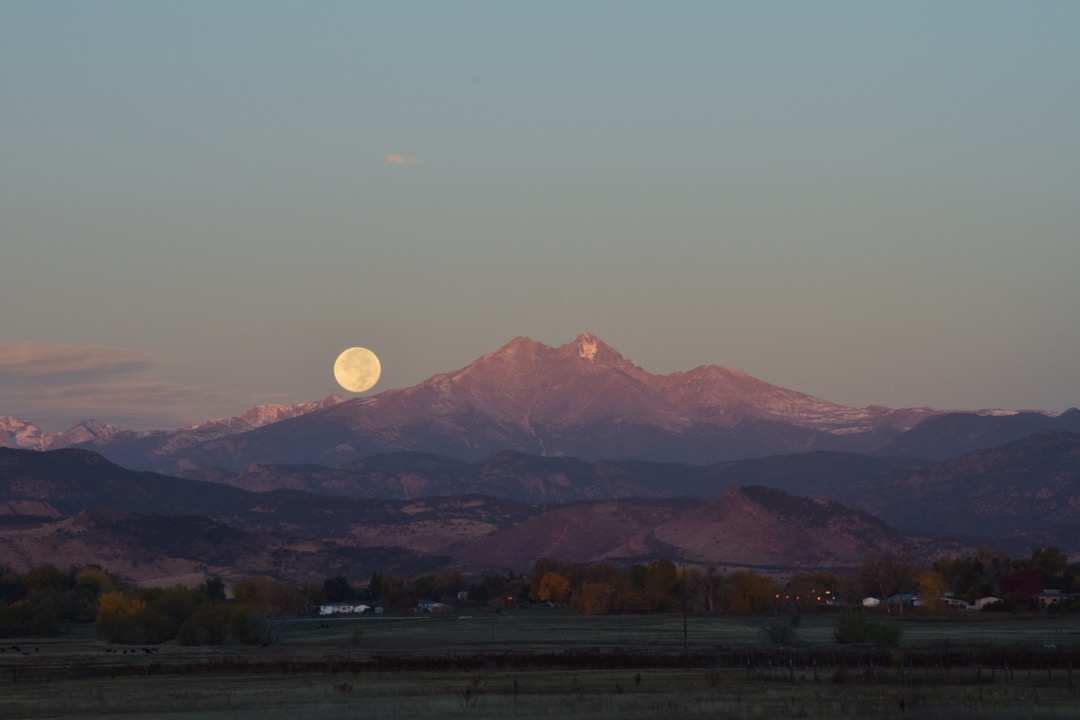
0,334,1080,581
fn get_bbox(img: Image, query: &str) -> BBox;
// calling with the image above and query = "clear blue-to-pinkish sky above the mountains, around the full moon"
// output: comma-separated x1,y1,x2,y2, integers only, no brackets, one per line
0,0,1080,430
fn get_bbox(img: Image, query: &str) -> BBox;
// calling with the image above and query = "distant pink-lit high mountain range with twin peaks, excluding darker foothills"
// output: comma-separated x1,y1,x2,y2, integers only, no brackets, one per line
6,334,1080,477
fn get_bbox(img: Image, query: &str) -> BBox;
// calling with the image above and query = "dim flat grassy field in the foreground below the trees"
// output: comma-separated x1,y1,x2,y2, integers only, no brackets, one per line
6,609,1080,720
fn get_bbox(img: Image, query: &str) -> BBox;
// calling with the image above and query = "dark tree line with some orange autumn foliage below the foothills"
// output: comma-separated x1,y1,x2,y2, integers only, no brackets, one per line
0,547,1080,644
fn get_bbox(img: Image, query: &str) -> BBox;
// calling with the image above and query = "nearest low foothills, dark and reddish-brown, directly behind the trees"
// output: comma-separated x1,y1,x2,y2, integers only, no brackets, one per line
0,449,973,584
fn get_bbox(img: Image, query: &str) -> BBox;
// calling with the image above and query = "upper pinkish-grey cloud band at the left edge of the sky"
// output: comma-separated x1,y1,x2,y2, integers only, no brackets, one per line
0,342,152,378
